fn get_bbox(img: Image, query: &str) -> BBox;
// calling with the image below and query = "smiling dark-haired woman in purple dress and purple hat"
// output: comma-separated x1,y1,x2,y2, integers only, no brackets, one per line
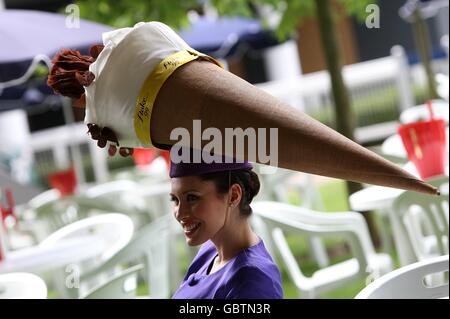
170,151,283,299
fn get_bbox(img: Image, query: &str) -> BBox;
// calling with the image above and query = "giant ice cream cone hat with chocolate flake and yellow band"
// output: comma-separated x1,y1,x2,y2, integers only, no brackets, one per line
49,22,437,194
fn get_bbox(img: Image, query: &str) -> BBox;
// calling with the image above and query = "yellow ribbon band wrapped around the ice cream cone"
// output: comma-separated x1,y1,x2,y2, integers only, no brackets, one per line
134,49,222,146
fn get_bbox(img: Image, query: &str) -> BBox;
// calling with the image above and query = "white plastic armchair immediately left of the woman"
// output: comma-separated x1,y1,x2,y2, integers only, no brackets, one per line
81,215,173,298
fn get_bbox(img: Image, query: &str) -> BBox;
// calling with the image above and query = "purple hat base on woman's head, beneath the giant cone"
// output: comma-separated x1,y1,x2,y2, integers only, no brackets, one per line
169,148,253,178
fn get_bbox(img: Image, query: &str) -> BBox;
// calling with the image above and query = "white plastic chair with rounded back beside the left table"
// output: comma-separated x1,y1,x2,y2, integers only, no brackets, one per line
40,213,134,298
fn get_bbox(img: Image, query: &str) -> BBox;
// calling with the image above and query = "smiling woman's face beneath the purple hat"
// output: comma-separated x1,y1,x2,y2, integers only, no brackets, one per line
170,176,228,246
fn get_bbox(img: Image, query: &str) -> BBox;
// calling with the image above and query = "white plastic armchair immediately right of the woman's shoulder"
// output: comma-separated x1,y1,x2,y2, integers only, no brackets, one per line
251,202,392,298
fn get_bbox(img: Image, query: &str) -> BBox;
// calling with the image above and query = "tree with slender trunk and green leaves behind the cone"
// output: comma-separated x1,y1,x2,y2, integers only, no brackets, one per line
78,0,378,242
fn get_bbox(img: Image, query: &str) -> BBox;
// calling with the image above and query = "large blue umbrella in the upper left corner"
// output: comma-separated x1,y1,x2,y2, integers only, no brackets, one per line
0,9,112,110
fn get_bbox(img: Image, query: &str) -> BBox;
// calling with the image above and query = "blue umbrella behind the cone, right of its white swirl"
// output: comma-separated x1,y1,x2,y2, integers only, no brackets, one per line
180,16,277,58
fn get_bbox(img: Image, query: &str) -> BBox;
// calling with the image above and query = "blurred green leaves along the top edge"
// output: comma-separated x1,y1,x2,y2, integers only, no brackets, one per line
76,0,376,39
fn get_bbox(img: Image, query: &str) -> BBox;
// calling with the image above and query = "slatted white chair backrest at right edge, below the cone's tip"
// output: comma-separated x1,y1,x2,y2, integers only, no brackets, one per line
393,176,449,260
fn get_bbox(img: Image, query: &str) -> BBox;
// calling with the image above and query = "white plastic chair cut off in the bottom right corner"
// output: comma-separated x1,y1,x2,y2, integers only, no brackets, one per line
355,255,449,299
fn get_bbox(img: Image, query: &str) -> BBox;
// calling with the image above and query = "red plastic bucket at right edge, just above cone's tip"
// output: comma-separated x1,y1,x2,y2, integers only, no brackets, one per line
398,119,446,179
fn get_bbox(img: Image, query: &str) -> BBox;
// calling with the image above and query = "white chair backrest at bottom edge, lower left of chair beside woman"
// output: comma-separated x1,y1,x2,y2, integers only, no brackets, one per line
81,265,143,299
